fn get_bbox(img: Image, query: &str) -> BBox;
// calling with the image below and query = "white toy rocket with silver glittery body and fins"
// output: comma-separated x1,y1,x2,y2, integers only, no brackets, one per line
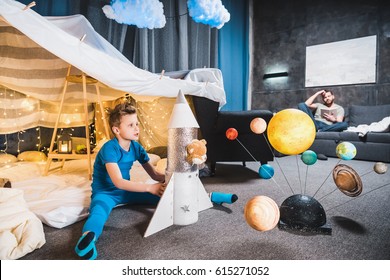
144,90,213,237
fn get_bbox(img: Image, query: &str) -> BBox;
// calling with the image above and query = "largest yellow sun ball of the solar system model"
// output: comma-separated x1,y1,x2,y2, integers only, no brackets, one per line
267,109,316,155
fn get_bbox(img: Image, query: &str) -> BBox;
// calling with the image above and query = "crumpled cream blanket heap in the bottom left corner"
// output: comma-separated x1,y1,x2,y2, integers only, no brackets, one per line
0,188,46,260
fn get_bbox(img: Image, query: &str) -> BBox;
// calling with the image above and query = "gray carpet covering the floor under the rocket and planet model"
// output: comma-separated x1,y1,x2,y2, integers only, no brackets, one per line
22,156,390,260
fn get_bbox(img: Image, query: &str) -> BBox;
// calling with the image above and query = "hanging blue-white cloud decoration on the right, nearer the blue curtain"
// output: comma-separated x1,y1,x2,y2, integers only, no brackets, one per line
187,0,230,29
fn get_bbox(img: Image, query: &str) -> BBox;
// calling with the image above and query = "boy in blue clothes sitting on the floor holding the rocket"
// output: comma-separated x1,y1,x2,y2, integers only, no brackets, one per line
75,104,165,260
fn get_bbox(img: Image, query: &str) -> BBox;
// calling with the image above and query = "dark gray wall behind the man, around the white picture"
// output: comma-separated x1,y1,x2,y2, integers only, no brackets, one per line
252,0,390,111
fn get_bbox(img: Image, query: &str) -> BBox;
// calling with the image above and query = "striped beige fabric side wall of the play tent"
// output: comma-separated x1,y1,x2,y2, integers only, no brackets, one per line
0,21,114,134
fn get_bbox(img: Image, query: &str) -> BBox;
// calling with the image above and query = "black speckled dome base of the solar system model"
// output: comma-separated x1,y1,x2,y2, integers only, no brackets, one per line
279,194,332,234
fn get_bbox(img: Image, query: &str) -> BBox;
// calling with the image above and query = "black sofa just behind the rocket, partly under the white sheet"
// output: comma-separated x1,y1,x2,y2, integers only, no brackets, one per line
192,96,274,175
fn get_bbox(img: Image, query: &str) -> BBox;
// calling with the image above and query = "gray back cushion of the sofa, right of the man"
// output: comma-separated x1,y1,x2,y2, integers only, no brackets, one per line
349,104,390,126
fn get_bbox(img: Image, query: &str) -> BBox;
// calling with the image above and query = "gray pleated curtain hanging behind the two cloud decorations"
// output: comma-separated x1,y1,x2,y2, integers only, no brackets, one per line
123,0,218,73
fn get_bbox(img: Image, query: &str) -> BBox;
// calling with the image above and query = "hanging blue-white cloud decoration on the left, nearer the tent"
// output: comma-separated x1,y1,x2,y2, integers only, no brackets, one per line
102,0,166,29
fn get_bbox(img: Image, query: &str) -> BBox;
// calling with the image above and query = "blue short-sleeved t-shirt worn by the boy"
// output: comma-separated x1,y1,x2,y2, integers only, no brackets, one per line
92,138,149,193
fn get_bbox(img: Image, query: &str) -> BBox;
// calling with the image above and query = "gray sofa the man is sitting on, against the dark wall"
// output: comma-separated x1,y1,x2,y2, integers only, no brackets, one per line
309,104,390,162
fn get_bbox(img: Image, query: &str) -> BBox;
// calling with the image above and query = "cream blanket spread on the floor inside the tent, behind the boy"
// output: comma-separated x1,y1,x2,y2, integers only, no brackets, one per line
0,154,160,228
